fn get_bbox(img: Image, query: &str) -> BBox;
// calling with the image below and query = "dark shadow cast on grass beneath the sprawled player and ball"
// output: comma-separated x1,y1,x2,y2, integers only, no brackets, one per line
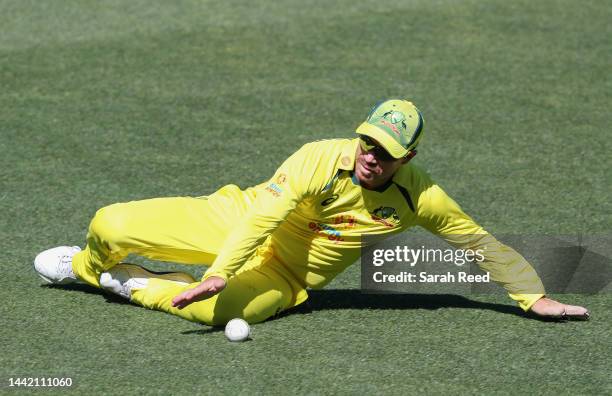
41,284,562,324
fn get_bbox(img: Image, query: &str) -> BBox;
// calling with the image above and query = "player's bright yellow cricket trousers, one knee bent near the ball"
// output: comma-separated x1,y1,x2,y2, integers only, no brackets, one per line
72,185,304,325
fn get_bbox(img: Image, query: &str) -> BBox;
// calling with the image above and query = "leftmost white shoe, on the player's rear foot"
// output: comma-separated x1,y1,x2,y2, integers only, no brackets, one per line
34,246,81,285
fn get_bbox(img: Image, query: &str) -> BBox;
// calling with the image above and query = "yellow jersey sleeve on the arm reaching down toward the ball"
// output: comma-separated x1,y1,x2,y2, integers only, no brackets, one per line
203,146,314,281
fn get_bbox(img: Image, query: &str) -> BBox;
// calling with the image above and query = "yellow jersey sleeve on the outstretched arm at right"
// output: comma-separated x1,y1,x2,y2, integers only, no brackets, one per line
417,175,544,311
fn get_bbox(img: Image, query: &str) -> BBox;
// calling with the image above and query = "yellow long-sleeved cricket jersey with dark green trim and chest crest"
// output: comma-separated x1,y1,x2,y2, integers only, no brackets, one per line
204,139,544,310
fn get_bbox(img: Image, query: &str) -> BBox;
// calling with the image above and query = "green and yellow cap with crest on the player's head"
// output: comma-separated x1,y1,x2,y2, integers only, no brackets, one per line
357,99,423,158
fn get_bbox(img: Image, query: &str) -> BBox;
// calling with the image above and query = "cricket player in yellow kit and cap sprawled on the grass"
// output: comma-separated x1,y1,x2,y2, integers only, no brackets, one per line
34,99,588,325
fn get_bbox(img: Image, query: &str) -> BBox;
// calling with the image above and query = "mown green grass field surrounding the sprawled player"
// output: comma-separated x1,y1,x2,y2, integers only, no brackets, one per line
0,0,612,395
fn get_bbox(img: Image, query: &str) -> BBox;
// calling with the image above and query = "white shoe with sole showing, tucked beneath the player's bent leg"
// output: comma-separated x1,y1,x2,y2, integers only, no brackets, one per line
100,263,195,300
